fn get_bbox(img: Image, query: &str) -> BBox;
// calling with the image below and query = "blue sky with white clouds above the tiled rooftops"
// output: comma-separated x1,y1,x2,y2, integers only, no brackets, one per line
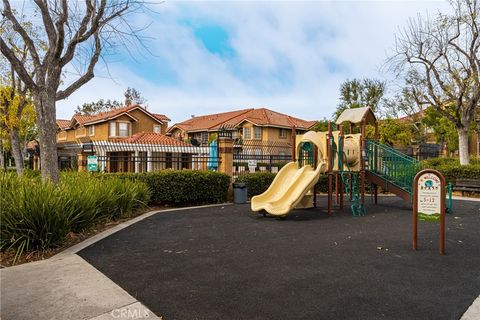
57,1,448,124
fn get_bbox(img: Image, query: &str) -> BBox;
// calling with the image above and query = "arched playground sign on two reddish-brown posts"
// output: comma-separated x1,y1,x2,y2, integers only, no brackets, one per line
412,169,446,254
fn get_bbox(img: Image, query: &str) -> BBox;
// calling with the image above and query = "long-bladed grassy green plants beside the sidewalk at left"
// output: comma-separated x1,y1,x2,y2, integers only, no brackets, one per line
0,173,150,256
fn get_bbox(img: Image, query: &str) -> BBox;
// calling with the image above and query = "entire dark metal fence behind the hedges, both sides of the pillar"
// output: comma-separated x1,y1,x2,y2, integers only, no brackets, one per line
68,139,326,179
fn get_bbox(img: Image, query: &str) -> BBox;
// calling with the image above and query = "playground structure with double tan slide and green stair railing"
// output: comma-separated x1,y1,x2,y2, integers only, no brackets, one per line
251,107,442,217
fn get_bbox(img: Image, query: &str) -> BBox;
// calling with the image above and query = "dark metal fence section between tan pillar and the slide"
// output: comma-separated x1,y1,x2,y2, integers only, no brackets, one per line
232,139,292,179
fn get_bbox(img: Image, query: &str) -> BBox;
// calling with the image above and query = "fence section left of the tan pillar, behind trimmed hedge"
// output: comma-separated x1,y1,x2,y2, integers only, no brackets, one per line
79,141,221,172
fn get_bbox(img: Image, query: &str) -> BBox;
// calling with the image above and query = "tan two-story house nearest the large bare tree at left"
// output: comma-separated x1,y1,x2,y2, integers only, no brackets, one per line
52,105,204,172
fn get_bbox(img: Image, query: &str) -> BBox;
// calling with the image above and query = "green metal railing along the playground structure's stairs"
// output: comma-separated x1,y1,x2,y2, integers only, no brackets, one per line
366,140,422,194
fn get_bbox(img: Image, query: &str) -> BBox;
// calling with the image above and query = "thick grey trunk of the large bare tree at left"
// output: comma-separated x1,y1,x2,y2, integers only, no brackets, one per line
33,90,59,183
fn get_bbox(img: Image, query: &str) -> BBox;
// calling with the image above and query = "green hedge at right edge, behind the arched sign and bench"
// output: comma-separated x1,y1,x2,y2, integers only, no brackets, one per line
423,158,480,182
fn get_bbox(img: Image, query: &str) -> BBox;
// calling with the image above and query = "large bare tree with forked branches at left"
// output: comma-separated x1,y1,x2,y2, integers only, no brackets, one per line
0,0,143,182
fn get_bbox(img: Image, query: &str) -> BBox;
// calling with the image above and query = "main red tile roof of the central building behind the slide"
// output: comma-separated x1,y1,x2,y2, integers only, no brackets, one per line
168,108,317,131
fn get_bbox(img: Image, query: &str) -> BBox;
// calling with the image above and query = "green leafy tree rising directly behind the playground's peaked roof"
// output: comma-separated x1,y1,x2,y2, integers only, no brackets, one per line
333,79,386,119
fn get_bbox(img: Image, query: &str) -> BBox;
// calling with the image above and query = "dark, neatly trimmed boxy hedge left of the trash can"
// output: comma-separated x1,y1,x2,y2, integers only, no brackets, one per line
102,170,231,205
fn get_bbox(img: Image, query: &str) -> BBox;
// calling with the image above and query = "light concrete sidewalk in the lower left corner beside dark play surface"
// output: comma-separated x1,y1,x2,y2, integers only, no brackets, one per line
0,254,159,320
